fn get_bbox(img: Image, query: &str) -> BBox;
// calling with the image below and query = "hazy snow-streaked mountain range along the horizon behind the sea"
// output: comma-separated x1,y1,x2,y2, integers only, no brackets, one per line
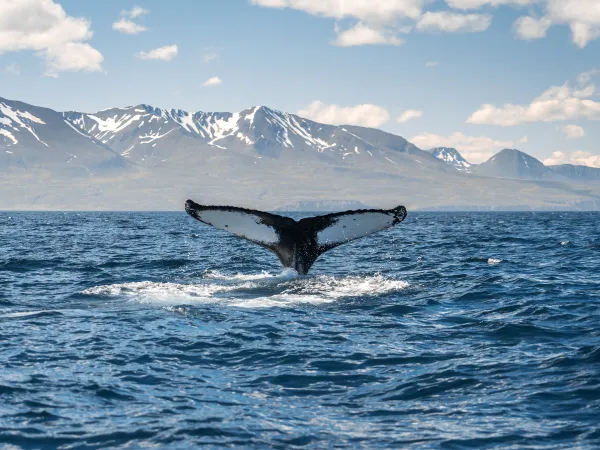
0,98,600,210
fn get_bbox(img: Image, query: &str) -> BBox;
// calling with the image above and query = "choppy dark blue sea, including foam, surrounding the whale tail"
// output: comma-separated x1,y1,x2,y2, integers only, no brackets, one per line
0,213,600,449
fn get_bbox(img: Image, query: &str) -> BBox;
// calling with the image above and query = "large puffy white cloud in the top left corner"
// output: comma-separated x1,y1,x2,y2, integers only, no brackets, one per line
0,0,104,76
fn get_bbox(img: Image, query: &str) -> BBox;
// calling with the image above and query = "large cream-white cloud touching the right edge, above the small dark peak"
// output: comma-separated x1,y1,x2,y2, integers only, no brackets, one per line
467,71,600,126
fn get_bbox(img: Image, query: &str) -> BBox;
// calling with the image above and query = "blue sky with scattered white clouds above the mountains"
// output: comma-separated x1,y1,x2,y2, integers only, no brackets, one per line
0,0,600,167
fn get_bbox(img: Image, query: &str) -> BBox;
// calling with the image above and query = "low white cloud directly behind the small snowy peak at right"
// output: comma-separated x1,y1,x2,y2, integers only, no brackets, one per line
409,132,514,164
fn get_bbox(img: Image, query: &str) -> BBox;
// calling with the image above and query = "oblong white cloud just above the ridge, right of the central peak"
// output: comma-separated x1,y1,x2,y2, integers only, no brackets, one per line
298,100,390,128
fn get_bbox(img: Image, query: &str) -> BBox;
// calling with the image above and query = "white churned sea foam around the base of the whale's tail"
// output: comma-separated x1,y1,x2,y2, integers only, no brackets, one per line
83,270,409,308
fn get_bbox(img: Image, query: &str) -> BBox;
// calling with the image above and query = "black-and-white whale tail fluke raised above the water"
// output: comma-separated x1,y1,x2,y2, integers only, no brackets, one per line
185,200,407,275
